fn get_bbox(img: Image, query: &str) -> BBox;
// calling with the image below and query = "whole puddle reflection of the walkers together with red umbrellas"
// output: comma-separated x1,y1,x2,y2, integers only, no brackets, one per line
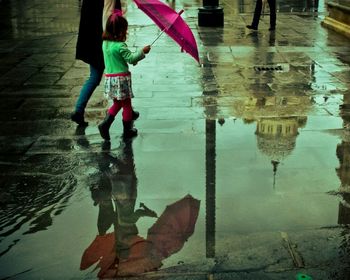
80,139,200,278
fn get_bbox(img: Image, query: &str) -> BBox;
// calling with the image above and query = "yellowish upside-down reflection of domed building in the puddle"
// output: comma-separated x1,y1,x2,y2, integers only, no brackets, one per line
233,95,312,161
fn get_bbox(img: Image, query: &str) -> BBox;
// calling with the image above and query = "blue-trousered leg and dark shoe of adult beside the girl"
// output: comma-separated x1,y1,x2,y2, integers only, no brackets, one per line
71,65,103,125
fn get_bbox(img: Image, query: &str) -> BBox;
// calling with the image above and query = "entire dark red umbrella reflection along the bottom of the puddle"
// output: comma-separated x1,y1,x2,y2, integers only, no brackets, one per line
81,195,200,278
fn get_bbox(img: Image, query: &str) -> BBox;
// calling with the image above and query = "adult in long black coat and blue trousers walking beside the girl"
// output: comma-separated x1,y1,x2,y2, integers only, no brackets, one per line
71,0,121,126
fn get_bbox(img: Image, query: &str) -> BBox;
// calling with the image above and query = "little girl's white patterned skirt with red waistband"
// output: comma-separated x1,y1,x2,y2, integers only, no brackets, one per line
104,73,134,100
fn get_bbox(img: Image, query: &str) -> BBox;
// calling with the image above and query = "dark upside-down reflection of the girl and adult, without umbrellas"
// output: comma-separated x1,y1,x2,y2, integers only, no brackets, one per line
91,139,157,259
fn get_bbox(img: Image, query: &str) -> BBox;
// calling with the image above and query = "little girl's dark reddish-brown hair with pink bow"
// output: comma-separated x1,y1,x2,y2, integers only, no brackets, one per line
102,10,128,41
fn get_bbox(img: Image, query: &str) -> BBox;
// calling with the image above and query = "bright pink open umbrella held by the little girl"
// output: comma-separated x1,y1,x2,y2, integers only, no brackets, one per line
134,0,199,63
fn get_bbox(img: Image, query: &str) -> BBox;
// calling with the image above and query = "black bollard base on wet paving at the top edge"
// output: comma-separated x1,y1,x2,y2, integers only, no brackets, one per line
198,0,224,27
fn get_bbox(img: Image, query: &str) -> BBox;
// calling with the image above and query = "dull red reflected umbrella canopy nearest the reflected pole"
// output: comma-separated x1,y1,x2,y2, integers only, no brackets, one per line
147,195,200,258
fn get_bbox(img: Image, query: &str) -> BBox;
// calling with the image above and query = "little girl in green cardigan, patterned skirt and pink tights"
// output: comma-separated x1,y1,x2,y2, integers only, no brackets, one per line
98,10,151,140
